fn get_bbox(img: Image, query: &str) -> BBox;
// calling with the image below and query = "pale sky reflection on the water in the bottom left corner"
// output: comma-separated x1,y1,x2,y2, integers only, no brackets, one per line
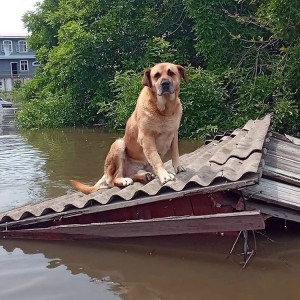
0,246,120,300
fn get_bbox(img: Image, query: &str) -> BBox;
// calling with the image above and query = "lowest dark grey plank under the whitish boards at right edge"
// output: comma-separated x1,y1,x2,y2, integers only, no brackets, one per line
247,199,300,222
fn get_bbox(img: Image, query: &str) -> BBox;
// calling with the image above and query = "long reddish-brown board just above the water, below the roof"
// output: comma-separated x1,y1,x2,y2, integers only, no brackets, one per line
0,211,265,239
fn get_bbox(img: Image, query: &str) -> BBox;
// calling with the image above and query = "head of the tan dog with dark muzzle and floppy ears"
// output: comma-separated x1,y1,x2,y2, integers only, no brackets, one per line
143,63,189,96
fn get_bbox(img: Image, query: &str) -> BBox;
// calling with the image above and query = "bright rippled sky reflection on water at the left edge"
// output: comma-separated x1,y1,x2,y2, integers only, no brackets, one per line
0,135,48,211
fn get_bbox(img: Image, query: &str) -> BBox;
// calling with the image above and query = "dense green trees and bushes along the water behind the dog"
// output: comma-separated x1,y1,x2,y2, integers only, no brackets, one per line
14,0,300,139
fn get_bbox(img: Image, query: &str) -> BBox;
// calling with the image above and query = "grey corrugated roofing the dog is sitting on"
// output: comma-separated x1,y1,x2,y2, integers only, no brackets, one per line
0,115,270,223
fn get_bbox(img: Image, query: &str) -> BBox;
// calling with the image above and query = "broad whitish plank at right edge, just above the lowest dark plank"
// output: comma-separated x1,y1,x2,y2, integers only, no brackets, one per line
241,178,300,210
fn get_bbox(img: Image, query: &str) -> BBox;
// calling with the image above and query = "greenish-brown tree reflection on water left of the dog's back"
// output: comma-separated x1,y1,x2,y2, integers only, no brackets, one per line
19,128,121,197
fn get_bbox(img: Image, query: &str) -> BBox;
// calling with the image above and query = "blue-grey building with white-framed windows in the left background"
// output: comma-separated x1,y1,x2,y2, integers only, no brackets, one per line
0,36,39,92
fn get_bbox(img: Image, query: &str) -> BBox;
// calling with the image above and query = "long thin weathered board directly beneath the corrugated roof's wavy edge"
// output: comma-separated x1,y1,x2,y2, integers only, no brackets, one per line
0,174,259,230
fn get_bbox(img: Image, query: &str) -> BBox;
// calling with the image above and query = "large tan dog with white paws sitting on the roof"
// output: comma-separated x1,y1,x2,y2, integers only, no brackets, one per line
71,63,188,194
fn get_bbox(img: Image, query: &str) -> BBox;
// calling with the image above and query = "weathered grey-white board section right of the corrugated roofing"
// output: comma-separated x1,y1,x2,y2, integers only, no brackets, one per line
242,132,300,210
